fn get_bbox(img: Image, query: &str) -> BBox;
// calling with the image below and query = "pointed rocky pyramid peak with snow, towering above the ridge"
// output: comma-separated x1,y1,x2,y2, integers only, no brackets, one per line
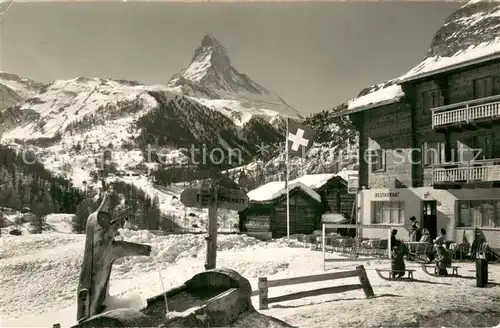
168,35,301,122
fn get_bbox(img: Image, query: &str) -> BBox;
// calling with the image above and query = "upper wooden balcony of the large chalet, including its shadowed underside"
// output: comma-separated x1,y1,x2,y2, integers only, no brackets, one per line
432,96,500,130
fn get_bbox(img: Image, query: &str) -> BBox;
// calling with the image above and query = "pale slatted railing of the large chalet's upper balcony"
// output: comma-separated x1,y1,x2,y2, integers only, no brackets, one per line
432,96,500,129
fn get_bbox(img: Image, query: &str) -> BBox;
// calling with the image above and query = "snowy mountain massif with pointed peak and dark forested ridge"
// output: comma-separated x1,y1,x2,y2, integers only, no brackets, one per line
0,36,310,226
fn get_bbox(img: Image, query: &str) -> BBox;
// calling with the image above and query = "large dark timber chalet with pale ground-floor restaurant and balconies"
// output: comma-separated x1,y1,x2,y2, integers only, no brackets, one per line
337,46,500,254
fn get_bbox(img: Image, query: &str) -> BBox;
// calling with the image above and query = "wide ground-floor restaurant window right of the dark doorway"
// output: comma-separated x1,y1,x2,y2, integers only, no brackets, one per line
457,199,500,228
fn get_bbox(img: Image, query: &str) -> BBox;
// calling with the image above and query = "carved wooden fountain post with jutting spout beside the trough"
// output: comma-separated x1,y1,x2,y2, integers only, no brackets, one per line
77,193,151,322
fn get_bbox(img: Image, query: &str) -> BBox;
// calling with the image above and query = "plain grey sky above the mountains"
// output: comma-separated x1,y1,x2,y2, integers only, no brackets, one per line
1,2,463,114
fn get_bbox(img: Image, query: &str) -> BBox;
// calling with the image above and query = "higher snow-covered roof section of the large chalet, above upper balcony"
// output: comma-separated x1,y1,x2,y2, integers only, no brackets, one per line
398,37,500,83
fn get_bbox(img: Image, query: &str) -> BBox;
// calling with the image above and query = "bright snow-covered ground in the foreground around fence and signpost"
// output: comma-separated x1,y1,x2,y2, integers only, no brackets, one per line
0,230,500,327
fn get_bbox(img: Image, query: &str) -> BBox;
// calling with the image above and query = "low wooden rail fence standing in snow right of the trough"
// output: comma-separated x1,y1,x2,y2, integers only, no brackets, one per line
259,265,375,310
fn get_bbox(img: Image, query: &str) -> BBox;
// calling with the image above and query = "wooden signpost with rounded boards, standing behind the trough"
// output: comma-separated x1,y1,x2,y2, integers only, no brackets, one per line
180,182,248,270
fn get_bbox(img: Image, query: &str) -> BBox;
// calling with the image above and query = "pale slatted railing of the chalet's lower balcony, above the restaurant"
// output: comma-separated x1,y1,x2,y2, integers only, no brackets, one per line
432,165,500,184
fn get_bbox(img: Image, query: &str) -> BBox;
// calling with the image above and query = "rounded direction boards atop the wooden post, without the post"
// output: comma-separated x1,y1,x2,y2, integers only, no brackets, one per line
180,188,249,211
